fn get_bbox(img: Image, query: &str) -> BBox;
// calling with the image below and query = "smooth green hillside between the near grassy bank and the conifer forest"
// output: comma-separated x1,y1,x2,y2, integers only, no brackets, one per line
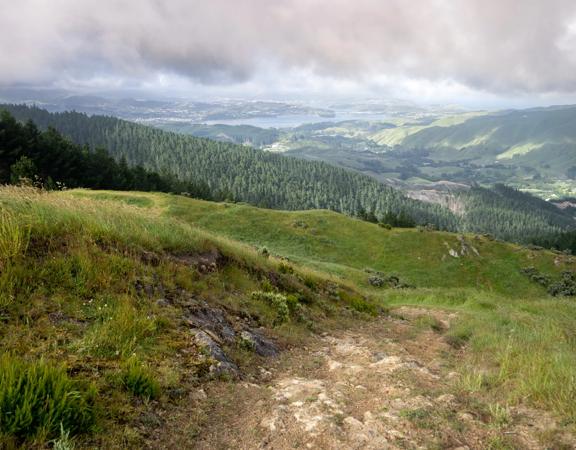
72,191,573,296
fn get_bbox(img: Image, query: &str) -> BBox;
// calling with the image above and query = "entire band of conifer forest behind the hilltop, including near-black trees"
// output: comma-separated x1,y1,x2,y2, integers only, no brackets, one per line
0,105,575,248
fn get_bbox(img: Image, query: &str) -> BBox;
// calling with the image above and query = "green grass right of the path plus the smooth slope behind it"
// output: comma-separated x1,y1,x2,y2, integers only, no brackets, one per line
68,193,576,422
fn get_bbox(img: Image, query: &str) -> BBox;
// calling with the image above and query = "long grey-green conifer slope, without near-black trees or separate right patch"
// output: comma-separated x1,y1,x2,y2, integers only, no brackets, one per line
3,105,457,230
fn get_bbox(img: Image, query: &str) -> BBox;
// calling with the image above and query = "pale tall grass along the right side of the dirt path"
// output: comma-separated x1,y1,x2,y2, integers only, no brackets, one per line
385,289,576,423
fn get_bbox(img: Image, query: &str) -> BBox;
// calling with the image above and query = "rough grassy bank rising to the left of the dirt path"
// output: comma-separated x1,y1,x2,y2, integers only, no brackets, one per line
0,187,378,448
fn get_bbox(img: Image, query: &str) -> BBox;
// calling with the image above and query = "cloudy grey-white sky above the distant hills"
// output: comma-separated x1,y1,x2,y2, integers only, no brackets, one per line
0,0,576,106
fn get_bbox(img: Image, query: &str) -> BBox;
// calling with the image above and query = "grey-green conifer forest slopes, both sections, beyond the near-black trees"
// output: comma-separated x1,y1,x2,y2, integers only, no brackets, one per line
2,105,575,246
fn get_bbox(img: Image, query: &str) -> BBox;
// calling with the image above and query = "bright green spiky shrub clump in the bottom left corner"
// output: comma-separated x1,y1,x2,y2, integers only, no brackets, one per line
0,354,95,441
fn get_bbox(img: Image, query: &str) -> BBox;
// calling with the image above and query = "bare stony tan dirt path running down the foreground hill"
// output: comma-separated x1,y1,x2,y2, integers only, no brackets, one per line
165,308,572,449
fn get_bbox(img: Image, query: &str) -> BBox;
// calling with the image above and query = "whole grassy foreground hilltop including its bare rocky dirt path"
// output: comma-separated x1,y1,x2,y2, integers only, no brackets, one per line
0,187,576,448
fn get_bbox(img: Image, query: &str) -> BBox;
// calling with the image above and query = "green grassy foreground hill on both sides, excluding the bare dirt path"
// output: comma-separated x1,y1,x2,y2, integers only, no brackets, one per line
0,187,576,448
